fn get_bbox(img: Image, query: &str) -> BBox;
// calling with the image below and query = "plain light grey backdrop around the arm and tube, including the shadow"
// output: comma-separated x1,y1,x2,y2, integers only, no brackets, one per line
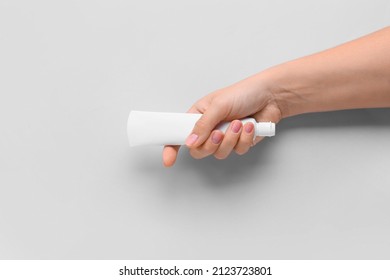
0,0,390,259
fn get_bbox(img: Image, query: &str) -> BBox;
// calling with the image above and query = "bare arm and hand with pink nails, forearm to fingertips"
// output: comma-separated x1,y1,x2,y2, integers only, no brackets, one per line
163,27,390,167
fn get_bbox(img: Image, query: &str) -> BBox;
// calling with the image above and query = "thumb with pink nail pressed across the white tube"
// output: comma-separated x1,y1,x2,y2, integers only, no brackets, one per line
186,102,228,148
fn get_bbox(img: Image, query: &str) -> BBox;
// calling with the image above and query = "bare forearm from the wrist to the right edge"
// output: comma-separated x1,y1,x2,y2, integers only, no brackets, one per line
257,27,390,118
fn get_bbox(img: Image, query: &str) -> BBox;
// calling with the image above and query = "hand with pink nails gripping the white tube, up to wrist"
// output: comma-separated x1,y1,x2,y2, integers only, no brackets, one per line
163,74,282,167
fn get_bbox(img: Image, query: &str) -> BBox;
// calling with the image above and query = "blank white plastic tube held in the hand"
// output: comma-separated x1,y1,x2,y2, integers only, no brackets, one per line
127,111,275,147
